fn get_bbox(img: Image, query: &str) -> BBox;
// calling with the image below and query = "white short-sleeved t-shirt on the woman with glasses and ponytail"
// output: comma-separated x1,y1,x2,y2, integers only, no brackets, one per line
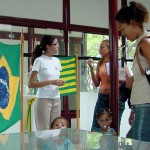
32,55,62,99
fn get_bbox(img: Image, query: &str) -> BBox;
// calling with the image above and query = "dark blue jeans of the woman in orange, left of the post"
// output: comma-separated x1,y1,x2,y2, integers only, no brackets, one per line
91,93,109,131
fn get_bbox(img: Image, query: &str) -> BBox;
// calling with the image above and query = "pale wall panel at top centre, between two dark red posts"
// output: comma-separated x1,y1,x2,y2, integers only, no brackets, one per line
70,0,109,28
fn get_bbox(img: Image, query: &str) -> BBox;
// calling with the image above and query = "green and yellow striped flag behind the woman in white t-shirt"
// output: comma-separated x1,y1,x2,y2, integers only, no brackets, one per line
59,56,76,96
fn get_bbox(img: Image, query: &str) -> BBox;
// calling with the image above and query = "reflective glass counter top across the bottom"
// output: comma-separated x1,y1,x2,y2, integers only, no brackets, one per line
0,128,150,150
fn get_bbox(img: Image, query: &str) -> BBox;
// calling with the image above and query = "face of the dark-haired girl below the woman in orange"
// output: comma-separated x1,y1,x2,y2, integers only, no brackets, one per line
98,114,112,131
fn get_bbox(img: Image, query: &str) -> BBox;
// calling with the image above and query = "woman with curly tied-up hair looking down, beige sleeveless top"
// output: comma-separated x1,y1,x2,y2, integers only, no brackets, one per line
115,1,150,142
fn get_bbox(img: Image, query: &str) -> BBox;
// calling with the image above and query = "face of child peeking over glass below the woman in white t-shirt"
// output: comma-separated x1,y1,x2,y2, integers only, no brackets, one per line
53,119,67,129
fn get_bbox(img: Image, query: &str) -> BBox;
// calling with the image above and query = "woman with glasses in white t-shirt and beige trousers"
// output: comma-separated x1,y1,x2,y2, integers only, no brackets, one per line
28,35,65,130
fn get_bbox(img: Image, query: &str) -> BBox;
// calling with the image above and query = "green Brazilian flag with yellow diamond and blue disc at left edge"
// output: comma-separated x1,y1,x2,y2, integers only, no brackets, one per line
0,42,21,132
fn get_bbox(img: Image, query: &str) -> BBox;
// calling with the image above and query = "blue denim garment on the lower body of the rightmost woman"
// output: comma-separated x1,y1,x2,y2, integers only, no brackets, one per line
127,103,150,142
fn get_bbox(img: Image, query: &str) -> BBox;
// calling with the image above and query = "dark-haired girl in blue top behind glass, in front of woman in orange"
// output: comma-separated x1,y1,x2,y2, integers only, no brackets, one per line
94,108,117,136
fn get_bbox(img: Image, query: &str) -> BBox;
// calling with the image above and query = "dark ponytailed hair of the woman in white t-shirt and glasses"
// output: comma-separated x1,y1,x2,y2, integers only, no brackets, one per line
31,35,55,65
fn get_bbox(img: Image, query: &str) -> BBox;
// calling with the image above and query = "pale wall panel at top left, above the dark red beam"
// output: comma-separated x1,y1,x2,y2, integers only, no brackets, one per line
0,0,63,22
